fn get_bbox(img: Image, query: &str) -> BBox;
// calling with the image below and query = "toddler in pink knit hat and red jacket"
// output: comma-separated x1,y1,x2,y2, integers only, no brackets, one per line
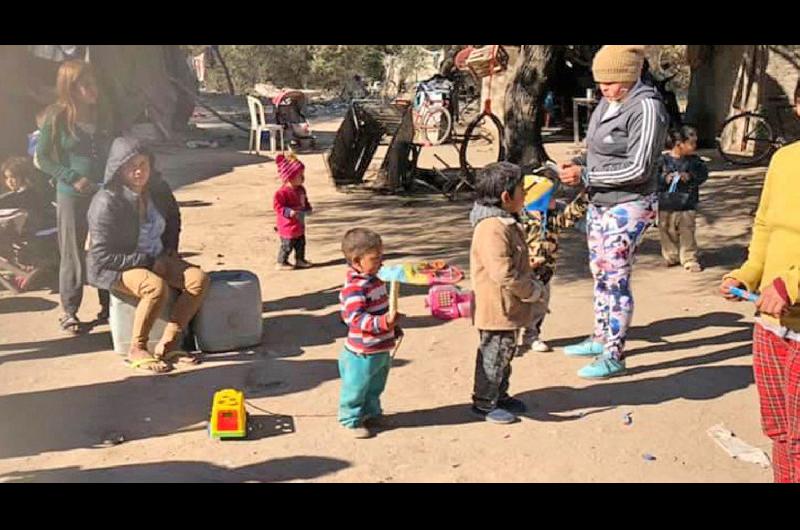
272,154,311,271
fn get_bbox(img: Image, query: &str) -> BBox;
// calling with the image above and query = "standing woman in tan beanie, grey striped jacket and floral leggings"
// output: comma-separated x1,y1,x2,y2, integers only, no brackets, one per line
560,45,669,379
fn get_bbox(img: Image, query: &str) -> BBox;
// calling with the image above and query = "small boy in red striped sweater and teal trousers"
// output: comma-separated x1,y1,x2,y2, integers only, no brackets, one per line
339,228,400,438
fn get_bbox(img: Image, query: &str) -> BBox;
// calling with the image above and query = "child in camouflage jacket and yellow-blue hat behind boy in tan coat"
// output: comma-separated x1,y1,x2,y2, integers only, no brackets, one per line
518,171,589,355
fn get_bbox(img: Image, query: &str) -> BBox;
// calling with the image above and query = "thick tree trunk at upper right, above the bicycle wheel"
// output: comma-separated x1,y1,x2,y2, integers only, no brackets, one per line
685,45,766,147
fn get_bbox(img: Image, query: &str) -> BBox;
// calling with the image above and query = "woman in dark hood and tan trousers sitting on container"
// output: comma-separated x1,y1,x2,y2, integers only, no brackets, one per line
87,138,209,373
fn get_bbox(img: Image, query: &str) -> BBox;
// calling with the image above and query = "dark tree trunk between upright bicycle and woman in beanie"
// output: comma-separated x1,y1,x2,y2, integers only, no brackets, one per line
505,45,561,166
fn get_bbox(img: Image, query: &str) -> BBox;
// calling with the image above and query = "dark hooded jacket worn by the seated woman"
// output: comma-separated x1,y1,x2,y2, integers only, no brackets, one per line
86,138,181,289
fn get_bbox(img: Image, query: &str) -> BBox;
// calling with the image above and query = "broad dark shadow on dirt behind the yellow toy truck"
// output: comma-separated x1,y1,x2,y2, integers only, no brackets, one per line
0,346,410,458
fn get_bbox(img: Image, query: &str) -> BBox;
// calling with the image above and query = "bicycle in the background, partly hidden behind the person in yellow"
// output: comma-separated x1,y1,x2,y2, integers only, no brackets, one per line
716,96,800,166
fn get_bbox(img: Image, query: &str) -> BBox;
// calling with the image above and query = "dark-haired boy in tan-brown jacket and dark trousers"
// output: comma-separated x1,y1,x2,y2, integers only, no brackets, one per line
470,162,544,424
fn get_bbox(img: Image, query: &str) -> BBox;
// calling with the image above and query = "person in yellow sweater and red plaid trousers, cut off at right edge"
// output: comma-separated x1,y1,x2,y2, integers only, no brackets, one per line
720,81,800,482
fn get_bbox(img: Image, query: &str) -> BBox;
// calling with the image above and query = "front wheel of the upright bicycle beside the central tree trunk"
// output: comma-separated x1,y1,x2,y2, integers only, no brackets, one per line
458,112,506,184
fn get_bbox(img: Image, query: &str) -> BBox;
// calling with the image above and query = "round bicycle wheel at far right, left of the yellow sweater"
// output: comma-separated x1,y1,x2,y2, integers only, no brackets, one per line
717,112,776,166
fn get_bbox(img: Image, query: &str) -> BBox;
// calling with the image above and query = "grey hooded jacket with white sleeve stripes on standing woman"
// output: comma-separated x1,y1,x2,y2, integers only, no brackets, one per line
575,82,669,206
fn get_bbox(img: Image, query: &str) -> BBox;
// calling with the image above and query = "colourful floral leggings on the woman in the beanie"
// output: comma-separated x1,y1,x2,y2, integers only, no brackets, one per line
586,195,658,360
